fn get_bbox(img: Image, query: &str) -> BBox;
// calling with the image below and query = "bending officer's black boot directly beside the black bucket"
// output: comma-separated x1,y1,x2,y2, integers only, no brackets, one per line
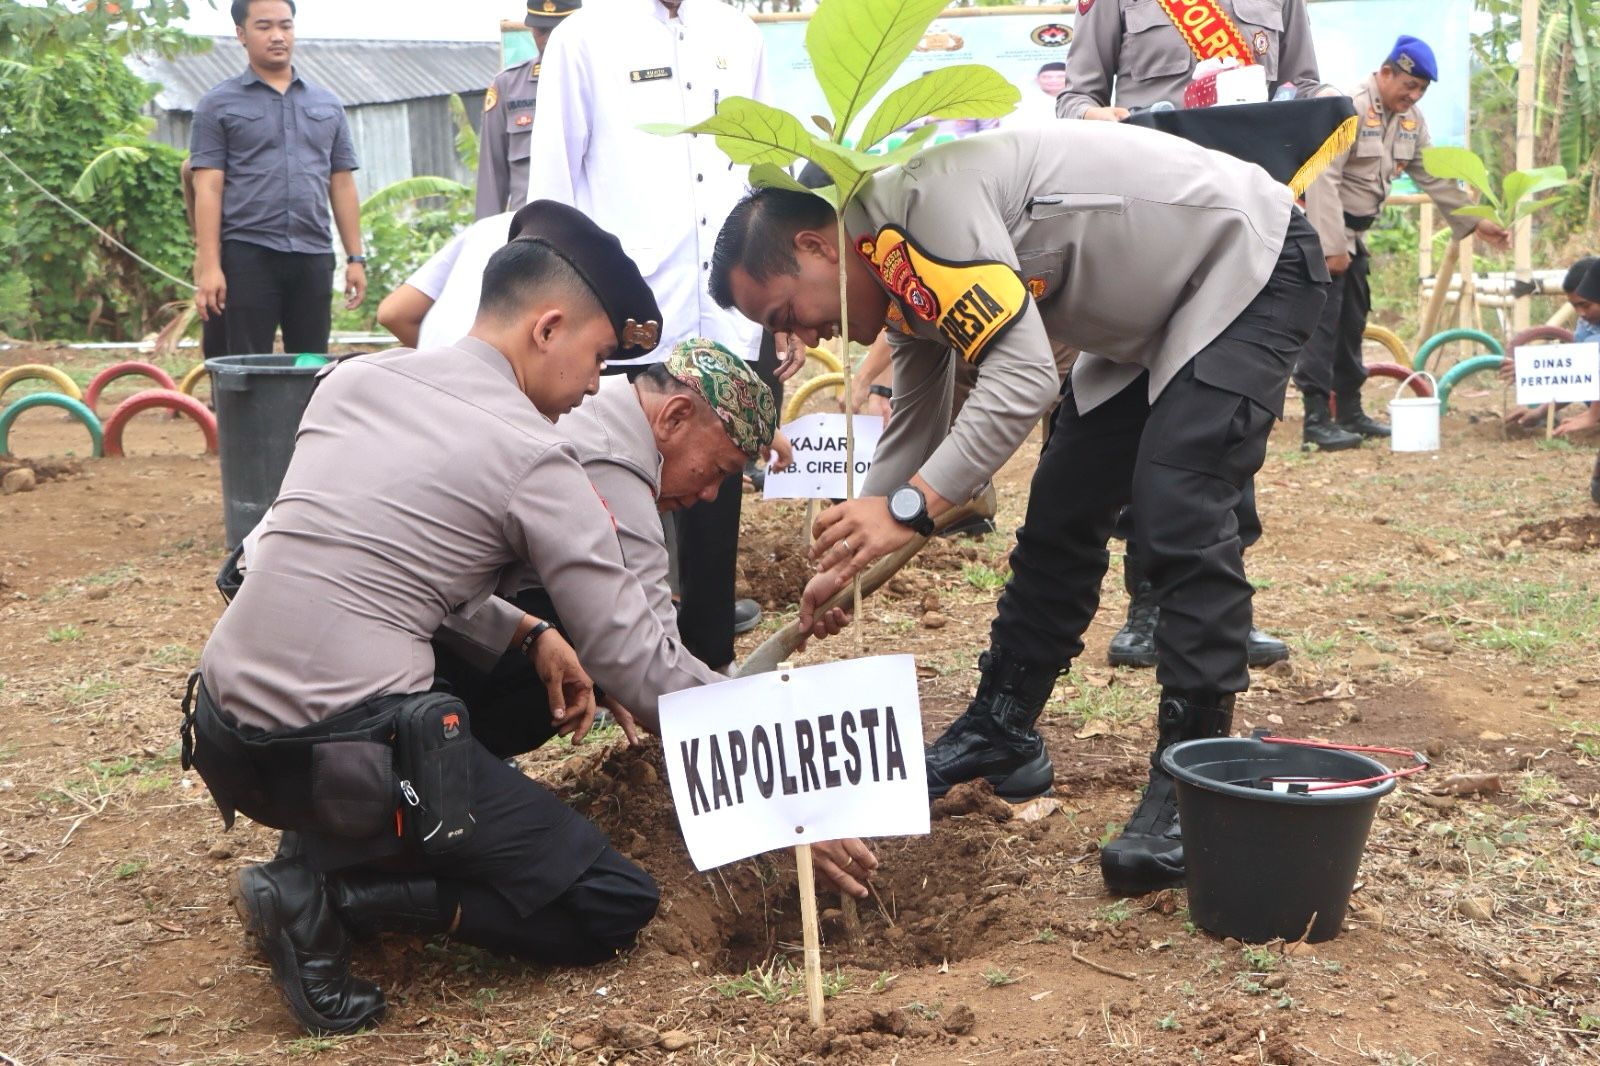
1101,688,1234,896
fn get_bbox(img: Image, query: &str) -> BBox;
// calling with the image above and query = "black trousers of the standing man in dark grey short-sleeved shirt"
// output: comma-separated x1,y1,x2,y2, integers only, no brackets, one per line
222,240,333,355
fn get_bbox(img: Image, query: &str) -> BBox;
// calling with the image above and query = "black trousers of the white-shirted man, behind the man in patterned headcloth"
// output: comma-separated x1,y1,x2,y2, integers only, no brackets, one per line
674,333,784,669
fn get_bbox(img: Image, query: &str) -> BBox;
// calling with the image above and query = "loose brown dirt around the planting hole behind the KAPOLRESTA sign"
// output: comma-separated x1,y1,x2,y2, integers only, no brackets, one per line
547,743,1091,973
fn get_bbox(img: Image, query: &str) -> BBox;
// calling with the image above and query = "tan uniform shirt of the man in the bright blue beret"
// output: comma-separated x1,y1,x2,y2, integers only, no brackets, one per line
1306,74,1478,256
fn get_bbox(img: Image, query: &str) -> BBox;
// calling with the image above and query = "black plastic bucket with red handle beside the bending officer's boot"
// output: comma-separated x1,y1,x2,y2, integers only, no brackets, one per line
1162,736,1395,943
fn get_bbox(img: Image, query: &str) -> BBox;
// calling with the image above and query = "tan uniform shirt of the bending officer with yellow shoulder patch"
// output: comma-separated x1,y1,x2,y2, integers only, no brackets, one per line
845,122,1293,501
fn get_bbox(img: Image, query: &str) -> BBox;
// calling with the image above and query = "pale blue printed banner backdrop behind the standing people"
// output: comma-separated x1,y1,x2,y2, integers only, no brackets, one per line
755,0,1472,144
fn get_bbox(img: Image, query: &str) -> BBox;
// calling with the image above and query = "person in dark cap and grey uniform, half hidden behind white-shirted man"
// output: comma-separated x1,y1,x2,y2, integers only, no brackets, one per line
475,0,582,218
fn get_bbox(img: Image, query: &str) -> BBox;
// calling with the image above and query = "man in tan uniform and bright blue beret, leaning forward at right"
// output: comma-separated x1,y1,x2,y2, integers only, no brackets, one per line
1294,35,1510,437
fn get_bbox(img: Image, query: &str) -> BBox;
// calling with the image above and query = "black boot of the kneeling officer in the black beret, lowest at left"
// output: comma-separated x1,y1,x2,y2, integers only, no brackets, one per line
234,860,384,1036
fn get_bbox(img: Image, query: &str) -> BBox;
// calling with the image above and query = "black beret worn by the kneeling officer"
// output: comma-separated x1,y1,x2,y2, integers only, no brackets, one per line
507,200,661,359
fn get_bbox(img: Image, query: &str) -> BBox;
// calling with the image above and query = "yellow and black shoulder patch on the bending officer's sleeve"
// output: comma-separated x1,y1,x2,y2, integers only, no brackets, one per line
856,226,1029,363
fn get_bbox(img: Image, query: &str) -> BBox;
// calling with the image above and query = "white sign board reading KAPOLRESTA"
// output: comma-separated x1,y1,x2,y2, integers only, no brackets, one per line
661,655,928,869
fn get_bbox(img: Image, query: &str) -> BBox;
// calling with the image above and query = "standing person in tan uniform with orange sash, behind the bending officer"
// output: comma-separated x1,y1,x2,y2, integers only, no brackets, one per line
1056,0,1318,666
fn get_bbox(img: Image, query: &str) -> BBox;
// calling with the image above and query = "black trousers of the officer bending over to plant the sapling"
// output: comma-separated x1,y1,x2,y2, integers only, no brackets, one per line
989,216,1326,693
